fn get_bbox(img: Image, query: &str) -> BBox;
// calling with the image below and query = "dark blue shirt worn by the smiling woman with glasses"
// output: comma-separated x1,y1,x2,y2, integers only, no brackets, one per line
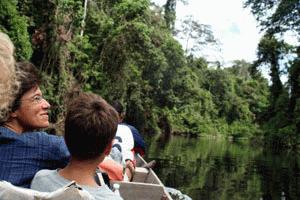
0,126,70,188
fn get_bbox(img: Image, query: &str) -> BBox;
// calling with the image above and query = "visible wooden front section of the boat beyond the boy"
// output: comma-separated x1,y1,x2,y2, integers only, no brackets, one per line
112,155,172,200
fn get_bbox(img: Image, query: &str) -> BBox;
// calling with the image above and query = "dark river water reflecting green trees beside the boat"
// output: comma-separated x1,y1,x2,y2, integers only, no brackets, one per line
146,136,300,200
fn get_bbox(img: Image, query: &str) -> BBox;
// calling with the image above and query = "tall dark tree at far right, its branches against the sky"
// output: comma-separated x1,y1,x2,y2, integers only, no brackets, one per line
244,0,300,146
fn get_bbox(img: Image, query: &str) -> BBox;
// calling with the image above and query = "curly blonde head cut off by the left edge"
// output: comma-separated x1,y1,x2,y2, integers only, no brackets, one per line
0,32,18,123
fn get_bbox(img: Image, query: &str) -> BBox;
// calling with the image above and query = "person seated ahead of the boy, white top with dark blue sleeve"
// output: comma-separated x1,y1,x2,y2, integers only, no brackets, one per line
99,101,145,181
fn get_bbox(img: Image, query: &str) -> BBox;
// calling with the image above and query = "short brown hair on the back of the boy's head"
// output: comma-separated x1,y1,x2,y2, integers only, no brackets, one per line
65,93,118,160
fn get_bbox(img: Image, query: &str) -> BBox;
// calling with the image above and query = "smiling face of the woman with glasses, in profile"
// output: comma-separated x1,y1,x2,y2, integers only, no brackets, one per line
12,86,50,132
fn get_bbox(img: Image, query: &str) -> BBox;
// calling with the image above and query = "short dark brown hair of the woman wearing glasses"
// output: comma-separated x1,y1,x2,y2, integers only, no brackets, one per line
12,62,41,112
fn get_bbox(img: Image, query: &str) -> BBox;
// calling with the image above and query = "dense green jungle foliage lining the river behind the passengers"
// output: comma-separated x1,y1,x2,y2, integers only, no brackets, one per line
0,0,300,145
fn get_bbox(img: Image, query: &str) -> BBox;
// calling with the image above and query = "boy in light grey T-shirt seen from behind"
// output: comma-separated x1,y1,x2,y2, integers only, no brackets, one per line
31,93,121,199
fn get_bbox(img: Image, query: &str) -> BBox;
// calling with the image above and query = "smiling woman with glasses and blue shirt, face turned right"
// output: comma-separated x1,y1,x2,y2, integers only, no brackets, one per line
0,62,69,188
